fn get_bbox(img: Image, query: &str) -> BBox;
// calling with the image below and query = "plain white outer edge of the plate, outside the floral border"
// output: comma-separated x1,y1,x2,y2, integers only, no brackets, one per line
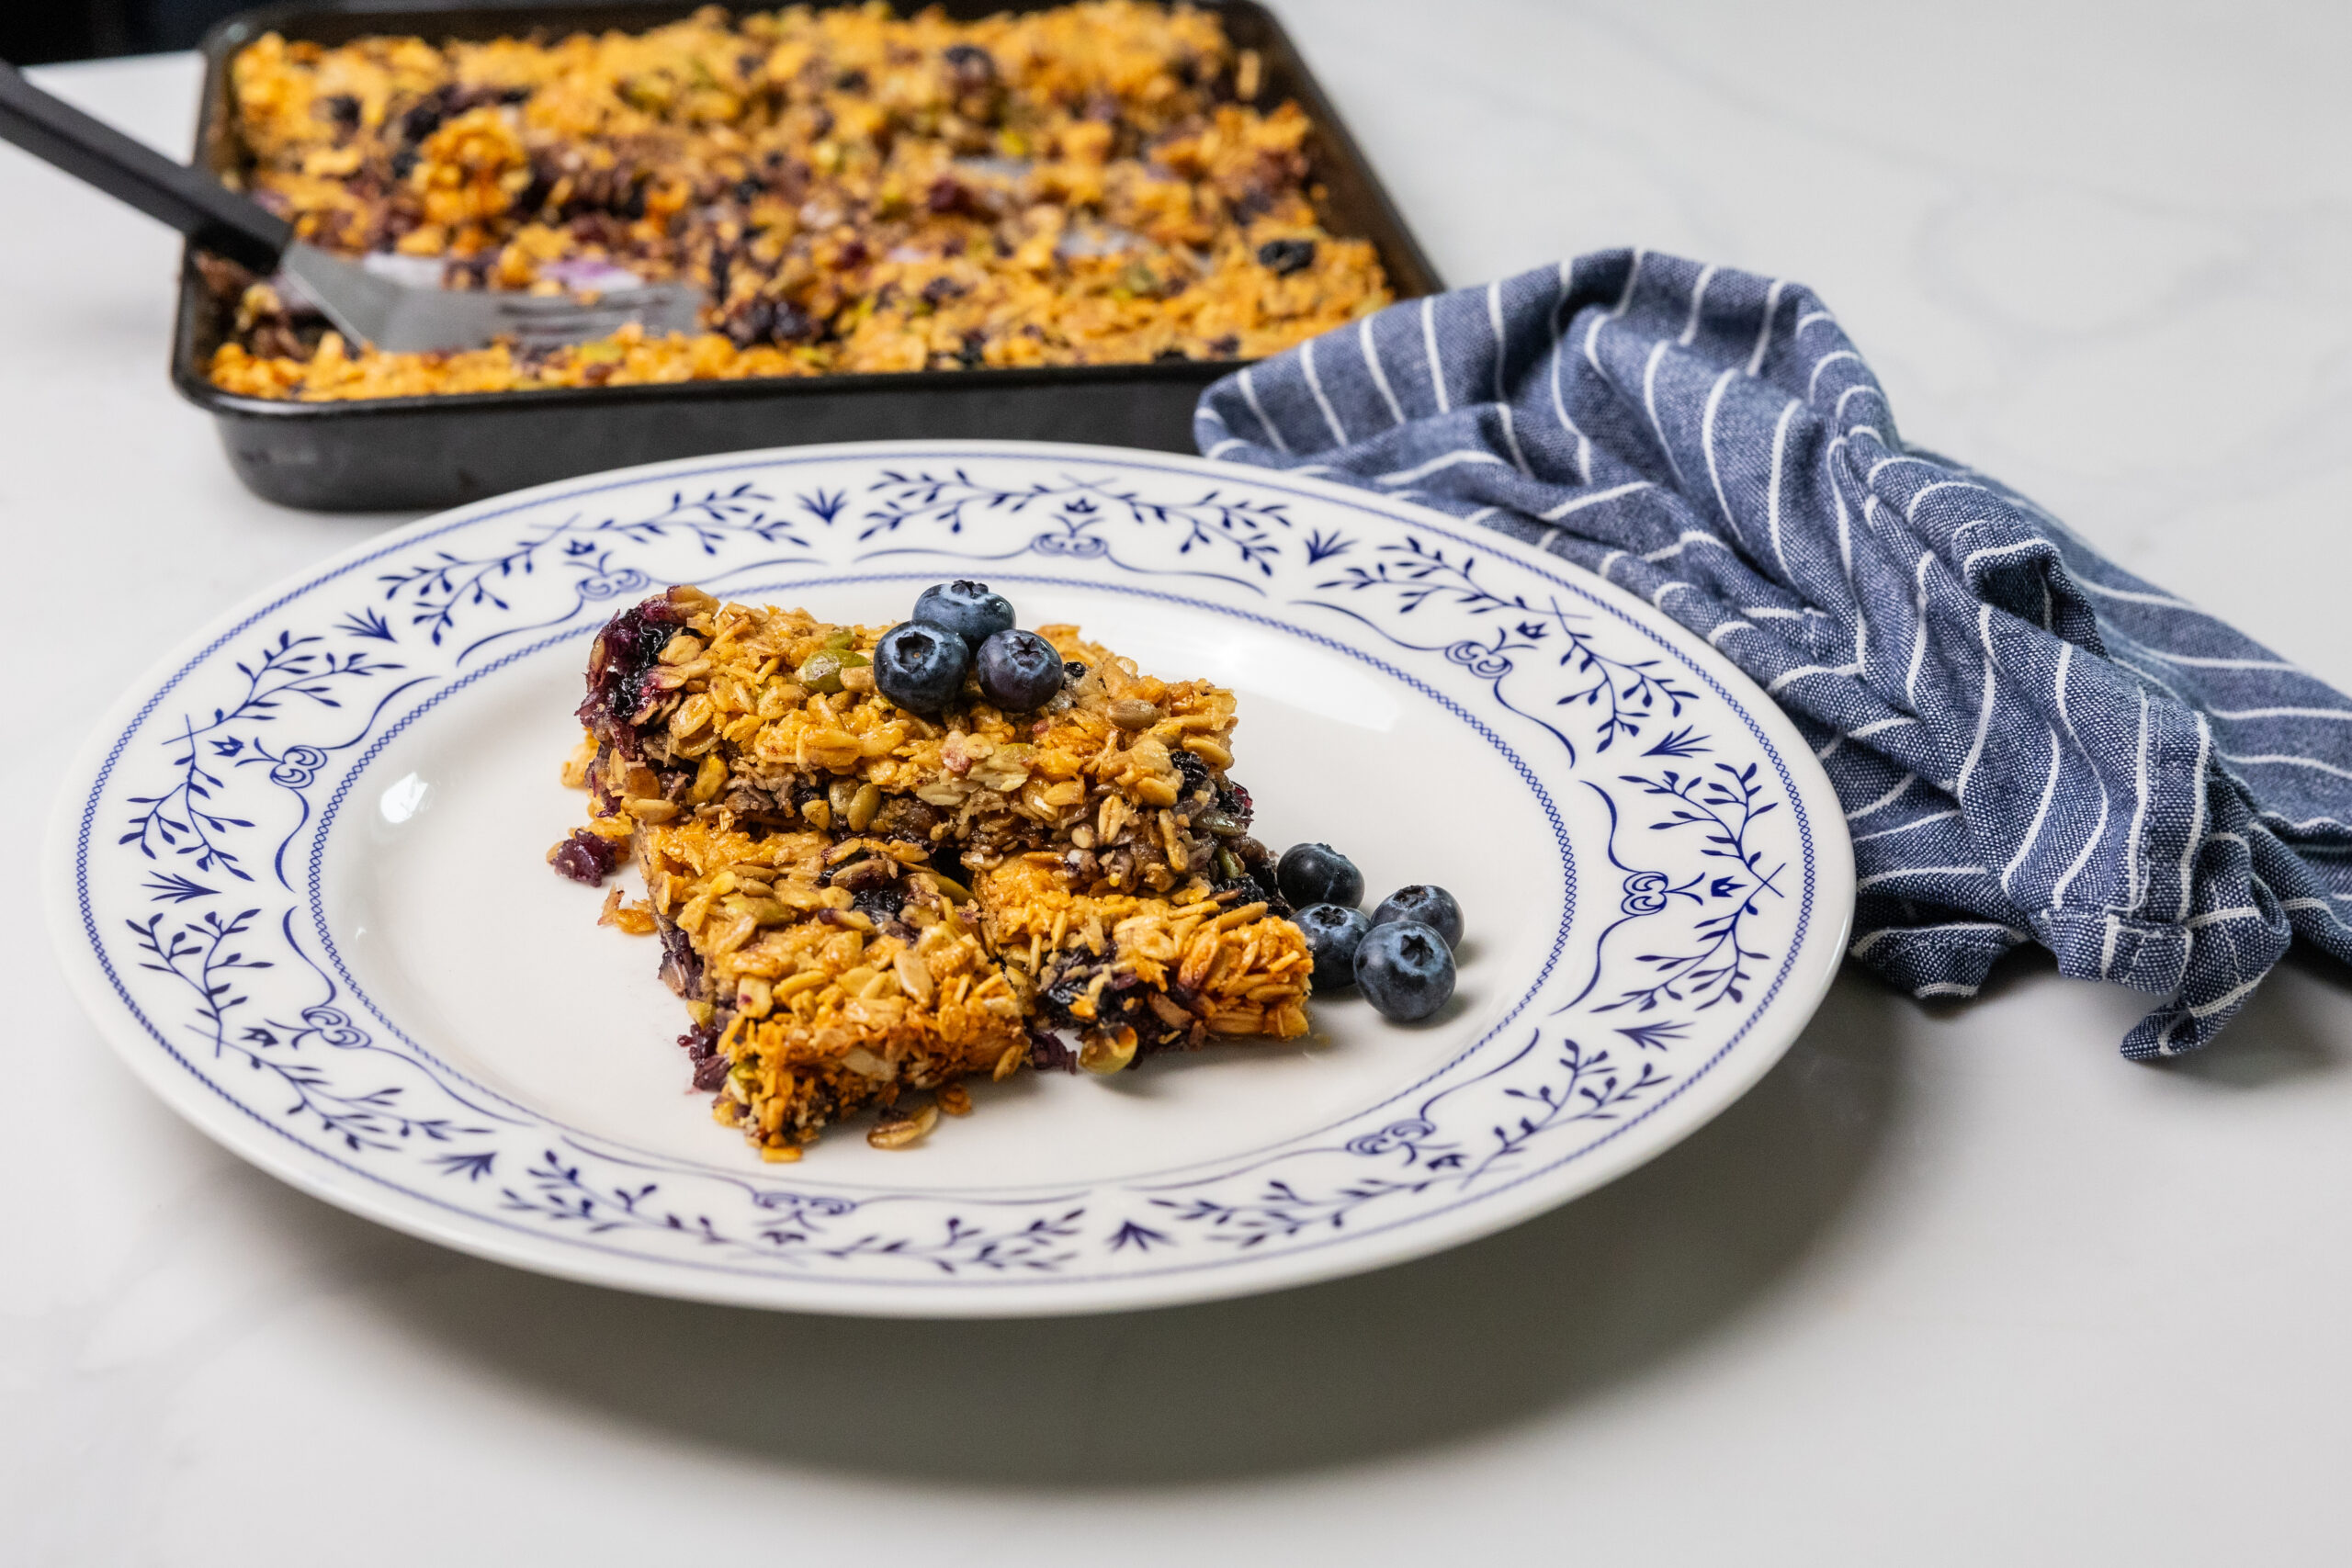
42,440,1853,1319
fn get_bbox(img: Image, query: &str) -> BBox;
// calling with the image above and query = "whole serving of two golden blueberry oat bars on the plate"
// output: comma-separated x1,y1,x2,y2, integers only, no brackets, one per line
555,588,1312,1156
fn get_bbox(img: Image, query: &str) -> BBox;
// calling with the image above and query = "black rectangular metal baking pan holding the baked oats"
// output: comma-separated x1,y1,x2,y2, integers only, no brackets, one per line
172,0,1442,510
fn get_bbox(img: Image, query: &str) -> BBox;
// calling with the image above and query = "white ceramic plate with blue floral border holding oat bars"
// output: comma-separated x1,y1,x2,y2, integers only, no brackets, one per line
50,445,1853,1316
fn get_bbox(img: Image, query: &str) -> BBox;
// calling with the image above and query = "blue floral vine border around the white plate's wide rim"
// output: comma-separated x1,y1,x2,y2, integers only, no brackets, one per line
73,449,1815,1286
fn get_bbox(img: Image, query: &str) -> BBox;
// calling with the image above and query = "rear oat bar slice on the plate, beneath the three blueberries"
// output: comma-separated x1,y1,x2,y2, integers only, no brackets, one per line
581,588,1286,893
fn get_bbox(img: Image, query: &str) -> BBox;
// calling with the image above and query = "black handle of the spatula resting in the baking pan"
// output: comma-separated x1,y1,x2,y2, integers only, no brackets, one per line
0,62,294,273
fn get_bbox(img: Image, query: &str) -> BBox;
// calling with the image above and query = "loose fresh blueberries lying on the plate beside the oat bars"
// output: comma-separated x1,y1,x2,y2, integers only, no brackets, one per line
1275,844,1463,1022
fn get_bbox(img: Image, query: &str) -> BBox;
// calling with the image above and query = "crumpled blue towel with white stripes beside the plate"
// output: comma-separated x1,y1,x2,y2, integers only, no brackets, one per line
1194,252,2352,1055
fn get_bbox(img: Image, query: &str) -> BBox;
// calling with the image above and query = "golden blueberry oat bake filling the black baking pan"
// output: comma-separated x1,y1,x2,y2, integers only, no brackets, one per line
205,0,1393,400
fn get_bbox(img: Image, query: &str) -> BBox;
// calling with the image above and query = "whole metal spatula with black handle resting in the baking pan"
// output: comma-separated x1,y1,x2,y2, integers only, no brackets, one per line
0,62,701,353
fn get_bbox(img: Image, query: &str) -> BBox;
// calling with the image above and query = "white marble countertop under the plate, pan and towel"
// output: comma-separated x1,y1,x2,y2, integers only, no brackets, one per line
0,0,2352,1568
